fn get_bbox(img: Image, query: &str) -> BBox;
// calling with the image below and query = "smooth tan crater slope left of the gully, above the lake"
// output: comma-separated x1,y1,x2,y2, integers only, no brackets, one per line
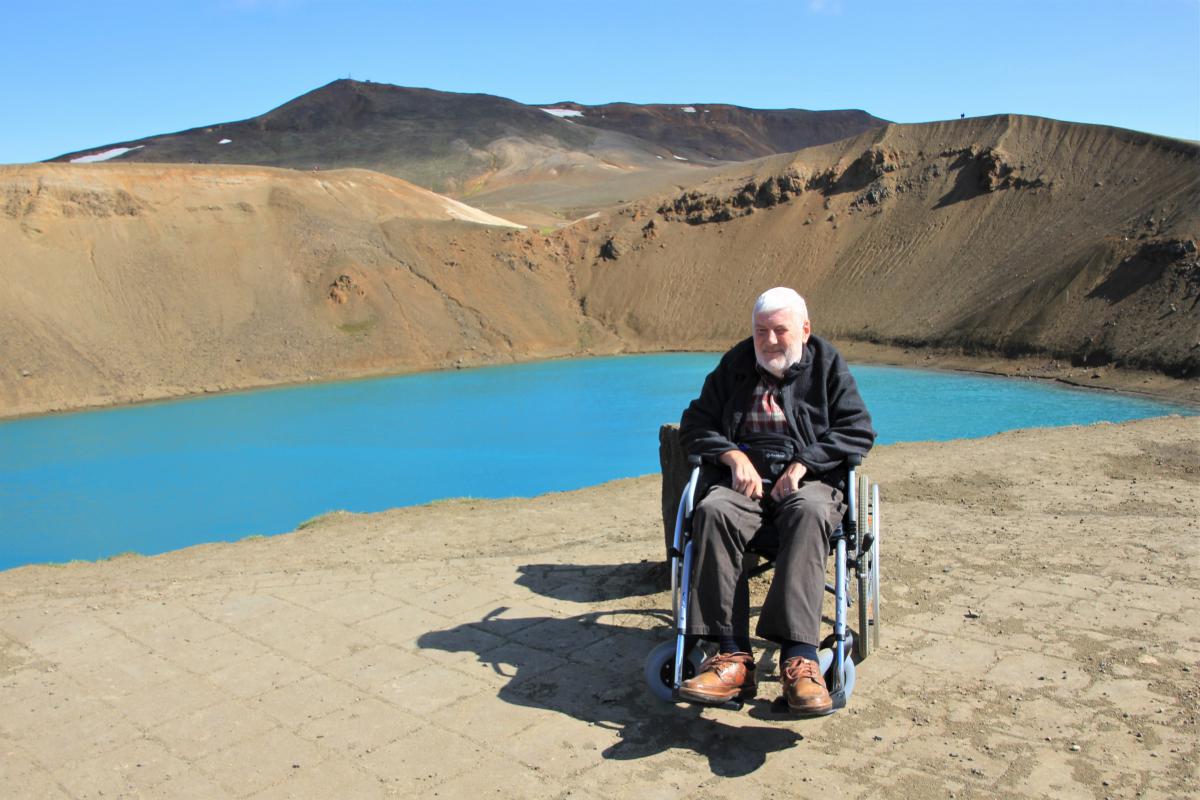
0,164,608,415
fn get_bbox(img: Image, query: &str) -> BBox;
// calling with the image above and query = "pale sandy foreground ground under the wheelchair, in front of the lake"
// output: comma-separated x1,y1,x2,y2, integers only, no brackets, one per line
0,417,1200,800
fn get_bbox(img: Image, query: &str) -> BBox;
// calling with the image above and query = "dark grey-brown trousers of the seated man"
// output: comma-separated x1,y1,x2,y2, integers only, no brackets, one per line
688,481,846,644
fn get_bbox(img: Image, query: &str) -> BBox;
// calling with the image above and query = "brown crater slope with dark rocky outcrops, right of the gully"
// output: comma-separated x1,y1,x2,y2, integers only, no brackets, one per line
566,116,1200,377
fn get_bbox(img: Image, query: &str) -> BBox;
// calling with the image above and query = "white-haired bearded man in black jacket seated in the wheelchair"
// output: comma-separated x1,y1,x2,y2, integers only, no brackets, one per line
679,287,875,715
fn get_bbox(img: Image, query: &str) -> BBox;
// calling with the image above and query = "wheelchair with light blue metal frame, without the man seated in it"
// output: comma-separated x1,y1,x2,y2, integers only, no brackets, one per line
644,456,881,711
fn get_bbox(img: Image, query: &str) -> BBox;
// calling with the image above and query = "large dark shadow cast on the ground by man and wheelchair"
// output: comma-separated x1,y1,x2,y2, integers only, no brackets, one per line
418,604,803,777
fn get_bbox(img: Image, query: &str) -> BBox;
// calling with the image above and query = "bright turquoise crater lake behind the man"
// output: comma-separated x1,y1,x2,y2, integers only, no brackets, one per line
0,354,1192,570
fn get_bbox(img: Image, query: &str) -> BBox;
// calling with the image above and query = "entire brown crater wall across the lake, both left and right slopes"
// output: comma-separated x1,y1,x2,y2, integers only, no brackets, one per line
0,117,1200,416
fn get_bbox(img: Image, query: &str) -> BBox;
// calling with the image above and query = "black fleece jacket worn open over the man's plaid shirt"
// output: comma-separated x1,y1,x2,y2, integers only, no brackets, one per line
679,336,875,477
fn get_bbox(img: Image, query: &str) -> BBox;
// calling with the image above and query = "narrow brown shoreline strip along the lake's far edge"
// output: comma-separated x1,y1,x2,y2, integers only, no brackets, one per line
7,339,1200,422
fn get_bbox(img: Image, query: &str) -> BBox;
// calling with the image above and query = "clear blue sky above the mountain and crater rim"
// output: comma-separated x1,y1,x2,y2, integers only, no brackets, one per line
0,0,1200,163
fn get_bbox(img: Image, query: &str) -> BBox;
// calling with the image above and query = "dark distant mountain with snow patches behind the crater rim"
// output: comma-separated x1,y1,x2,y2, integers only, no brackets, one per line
48,79,883,222
